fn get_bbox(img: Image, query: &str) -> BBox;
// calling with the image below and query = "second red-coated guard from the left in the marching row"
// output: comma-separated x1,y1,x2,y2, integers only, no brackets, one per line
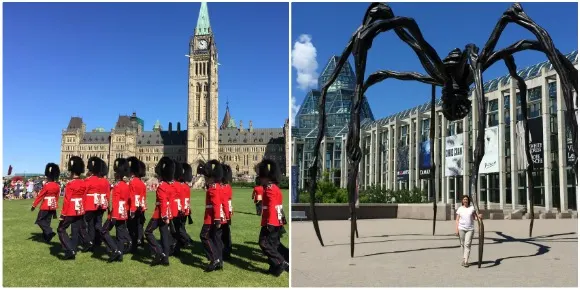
57,156,85,260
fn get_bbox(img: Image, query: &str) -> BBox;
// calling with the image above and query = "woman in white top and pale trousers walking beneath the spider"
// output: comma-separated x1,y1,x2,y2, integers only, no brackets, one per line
455,195,482,268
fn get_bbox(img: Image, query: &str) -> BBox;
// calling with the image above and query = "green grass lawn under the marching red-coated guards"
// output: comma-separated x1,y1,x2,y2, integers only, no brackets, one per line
3,188,290,287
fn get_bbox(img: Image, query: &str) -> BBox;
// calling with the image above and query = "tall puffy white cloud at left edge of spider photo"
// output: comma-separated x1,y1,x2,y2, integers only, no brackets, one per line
292,34,318,90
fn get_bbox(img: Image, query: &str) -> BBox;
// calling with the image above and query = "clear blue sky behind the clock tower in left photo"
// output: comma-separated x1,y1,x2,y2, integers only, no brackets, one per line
3,3,289,173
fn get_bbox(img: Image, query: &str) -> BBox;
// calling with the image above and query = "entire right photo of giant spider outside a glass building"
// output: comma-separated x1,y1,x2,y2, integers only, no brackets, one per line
290,2,578,287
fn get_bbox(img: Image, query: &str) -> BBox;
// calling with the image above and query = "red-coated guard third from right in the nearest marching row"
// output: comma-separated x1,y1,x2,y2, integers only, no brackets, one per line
145,157,175,266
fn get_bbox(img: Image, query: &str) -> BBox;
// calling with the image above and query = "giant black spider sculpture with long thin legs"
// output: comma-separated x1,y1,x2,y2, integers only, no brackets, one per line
309,3,578,267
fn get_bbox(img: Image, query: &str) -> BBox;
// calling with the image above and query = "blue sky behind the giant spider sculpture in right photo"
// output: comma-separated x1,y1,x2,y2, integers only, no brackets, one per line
292,3,578,123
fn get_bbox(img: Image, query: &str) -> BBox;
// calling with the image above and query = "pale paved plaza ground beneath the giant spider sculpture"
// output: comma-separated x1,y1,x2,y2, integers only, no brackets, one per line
291,219,578,287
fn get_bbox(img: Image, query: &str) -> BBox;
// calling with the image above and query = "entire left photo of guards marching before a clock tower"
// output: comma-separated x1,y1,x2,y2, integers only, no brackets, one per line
2,2,290,287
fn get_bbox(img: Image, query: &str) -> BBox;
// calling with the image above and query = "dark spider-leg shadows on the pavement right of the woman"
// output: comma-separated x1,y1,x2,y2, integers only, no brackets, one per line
469,231,578,268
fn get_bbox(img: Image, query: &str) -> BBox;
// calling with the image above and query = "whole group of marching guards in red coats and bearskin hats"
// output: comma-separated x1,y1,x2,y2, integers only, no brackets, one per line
31,156,289,276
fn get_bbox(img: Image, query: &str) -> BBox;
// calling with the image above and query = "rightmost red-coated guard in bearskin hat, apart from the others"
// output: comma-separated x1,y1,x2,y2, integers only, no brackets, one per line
258,159,290,277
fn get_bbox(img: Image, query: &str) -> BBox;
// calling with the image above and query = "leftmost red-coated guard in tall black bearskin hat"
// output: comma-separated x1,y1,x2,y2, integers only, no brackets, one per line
30,163,60,243
